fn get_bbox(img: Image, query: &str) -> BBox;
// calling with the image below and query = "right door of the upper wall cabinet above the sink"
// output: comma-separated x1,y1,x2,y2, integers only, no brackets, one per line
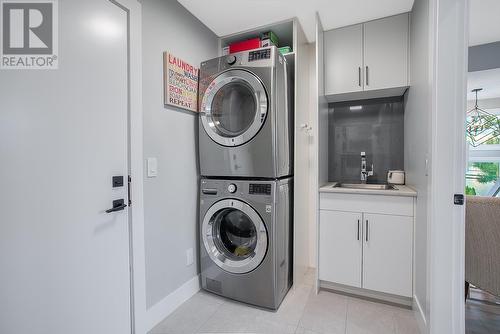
364,13,409,90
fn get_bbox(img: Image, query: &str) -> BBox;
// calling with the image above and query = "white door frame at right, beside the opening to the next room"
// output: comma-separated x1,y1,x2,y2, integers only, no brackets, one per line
427,0,468,334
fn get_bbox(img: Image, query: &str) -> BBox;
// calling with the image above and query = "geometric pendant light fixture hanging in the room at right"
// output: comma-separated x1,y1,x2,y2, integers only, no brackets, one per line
467,88,500,147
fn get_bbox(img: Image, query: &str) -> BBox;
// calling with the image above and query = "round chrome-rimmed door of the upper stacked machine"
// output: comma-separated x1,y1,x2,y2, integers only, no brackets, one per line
200,70,268,146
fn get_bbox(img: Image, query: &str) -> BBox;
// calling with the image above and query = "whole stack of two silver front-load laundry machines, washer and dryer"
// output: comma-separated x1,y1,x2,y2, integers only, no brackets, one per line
199,47,293,309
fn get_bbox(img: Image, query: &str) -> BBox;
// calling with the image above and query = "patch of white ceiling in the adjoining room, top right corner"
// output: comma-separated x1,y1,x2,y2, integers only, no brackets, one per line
469,0,500,45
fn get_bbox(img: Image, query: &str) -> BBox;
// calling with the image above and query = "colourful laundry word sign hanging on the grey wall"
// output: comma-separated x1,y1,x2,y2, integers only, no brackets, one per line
163,52,199,112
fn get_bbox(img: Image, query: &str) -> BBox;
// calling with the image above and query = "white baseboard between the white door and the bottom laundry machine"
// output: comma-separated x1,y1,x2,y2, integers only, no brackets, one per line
146,275,200,333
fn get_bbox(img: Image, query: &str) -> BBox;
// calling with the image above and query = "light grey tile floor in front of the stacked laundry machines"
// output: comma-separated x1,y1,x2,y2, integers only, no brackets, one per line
150,272,419,334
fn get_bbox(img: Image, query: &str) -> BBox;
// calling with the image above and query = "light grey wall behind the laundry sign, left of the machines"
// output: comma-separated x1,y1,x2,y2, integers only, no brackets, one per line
142,0,217,308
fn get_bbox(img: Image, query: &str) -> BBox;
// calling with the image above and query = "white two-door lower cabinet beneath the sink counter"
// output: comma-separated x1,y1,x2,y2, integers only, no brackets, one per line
318,193,413,298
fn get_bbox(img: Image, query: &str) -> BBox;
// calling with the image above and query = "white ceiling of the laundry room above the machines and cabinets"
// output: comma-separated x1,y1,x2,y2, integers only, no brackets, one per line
178,0,412,42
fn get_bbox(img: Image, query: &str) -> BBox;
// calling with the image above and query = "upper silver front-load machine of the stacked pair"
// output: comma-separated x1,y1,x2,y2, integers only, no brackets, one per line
199,46,293,178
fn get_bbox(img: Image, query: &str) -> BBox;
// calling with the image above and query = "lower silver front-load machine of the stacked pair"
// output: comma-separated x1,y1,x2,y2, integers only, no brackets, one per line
200,178,293,309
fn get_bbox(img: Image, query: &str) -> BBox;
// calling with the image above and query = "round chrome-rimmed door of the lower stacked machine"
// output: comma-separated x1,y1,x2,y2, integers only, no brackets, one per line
202,199,268,274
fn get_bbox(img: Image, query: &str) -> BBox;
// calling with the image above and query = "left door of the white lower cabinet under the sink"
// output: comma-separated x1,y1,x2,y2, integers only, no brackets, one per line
319,210,363,287
